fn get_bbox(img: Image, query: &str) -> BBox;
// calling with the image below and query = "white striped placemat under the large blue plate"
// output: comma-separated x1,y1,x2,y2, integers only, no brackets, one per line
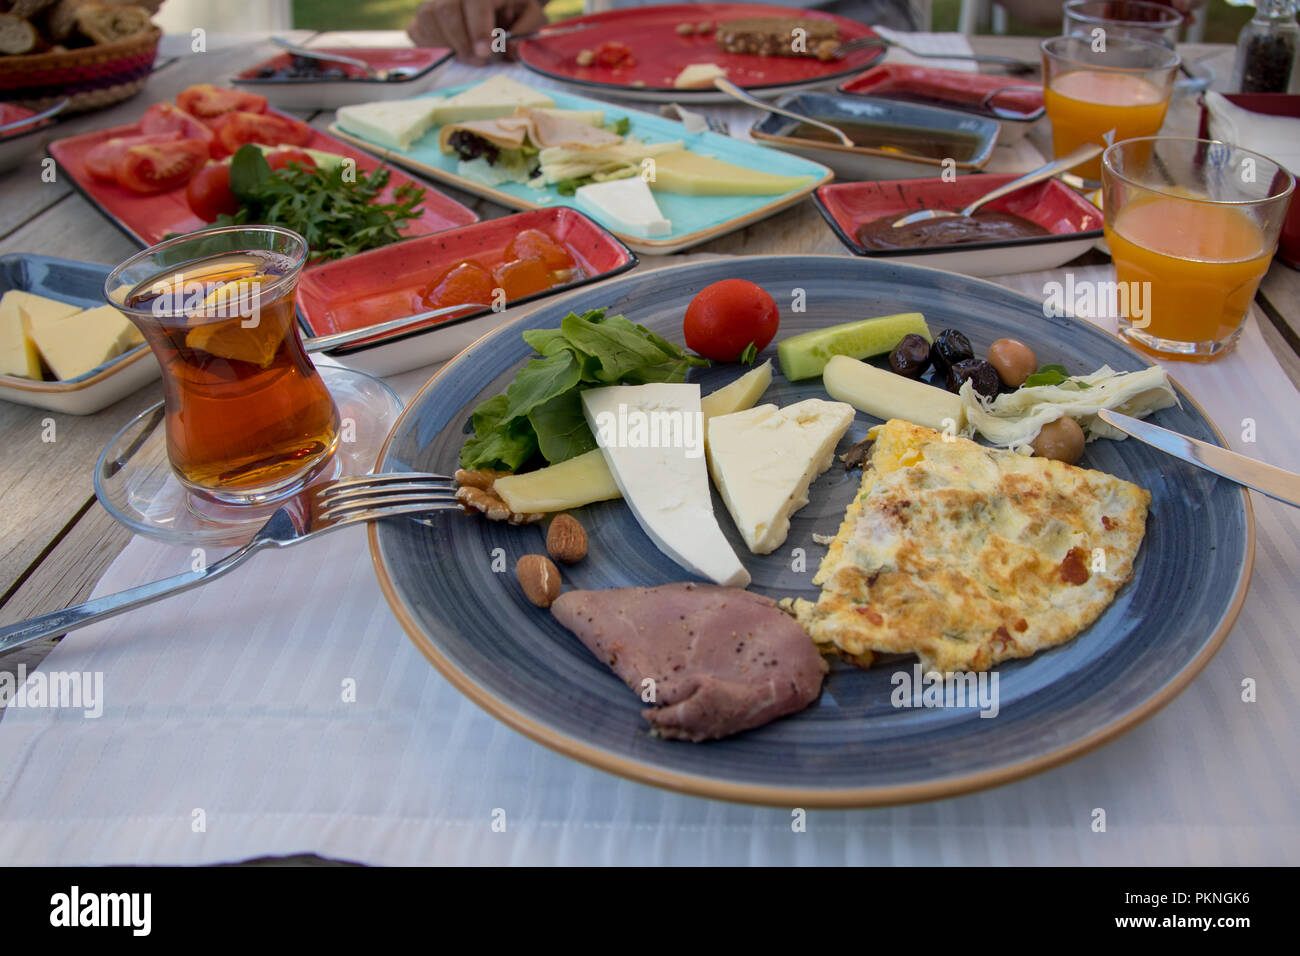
0,268,1300,865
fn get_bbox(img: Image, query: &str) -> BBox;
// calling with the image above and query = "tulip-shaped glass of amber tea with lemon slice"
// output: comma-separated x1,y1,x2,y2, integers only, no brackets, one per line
109,233,339,502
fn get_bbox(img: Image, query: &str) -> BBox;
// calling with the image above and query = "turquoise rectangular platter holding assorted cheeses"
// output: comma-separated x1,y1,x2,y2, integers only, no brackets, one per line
330,83,833,255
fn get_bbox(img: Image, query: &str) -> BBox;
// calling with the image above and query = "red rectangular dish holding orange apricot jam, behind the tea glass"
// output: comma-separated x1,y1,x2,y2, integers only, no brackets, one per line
298,206,637,355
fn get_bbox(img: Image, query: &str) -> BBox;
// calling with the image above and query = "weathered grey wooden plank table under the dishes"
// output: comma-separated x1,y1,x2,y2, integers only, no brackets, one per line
0,33,1300,785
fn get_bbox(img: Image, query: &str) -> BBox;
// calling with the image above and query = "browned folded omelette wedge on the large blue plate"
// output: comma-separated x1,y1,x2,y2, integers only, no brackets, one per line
789,419,1151,672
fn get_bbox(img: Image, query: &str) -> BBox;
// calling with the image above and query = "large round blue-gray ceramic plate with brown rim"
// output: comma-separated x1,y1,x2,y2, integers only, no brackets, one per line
371,256,1255,806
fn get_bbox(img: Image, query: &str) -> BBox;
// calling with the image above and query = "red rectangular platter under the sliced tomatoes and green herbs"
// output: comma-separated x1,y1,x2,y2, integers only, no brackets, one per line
48,111,478,246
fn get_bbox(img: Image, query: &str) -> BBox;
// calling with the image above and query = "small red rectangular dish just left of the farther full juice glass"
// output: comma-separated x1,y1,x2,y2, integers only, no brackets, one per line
839,64,1044,120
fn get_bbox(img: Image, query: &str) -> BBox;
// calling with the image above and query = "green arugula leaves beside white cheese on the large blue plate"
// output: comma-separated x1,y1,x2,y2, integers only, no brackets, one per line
460,308,709,471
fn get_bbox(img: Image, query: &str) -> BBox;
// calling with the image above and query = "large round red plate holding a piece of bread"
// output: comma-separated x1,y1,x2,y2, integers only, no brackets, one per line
517,4,884,95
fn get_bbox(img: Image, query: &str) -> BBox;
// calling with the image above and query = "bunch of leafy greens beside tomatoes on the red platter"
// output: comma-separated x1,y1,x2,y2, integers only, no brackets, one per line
217,144,425,261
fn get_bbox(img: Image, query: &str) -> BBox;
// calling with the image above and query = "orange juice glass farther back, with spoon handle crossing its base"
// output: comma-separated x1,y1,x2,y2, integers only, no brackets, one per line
1043,35,1182,179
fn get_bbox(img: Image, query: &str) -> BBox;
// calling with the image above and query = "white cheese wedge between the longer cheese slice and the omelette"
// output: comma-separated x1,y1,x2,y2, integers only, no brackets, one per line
709,398,853,554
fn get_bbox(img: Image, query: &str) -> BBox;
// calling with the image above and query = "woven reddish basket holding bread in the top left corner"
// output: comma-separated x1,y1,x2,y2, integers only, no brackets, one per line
0,26,163,113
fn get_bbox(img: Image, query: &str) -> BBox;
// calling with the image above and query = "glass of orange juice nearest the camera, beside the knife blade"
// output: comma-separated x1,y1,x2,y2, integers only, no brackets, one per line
1101,137,1295,362
